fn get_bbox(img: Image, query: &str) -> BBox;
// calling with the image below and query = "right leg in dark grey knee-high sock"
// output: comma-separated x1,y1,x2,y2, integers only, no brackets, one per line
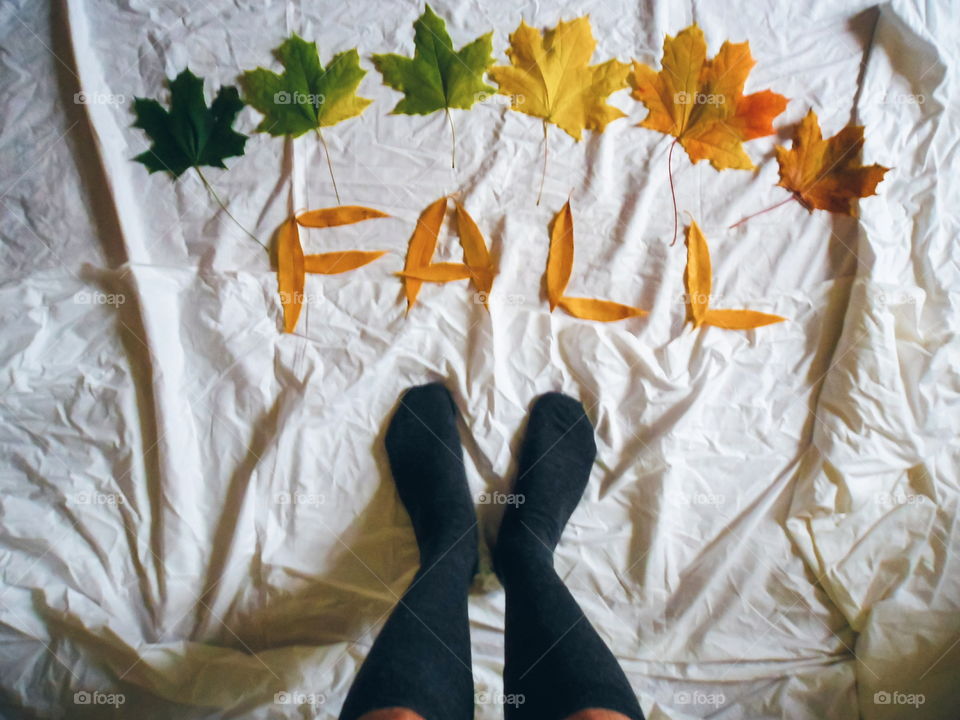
493,393,643,720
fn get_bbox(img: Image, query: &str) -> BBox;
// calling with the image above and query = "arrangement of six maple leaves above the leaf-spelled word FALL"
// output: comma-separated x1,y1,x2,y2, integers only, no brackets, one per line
134,5,888,332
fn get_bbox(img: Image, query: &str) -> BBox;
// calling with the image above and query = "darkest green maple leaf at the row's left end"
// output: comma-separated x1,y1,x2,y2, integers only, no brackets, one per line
133,68,247,178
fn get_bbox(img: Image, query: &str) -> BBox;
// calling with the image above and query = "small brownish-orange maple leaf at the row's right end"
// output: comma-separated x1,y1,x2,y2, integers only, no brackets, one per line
775,110,890,216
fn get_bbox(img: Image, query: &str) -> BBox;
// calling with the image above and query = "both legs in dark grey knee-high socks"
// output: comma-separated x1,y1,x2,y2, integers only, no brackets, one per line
340,383,643,720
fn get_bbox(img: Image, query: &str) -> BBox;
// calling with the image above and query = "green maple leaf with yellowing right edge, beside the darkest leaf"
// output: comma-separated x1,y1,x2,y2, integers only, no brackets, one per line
240,33,373,137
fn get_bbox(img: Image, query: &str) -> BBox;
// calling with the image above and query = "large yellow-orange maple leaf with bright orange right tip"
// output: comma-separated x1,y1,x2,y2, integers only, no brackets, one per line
628,24,787,170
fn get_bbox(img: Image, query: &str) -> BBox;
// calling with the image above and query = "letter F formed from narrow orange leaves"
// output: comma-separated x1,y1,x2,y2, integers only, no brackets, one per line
277,205,389,333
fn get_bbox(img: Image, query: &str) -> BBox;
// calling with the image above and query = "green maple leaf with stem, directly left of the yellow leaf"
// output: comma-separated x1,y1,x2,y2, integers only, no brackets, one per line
373,5,496,167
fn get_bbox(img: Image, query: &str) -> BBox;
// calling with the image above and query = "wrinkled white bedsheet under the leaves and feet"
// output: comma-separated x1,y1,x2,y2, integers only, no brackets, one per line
0,0,960,720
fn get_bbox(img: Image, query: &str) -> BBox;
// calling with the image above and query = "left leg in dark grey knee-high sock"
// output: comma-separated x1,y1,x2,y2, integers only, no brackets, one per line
340,383,477,720
